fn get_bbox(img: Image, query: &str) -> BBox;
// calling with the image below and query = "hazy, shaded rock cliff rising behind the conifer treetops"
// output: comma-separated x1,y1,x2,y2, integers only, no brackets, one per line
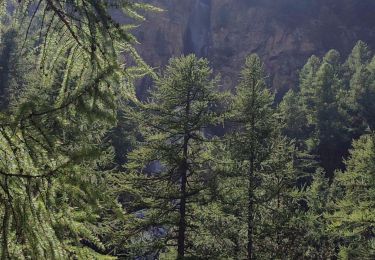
136,0,375,95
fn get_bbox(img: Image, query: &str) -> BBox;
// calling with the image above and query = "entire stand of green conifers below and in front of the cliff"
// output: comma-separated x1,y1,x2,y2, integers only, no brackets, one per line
0,0,375,260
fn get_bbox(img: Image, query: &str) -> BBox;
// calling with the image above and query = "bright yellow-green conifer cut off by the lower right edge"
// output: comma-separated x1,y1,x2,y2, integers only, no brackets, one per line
329,134,375,259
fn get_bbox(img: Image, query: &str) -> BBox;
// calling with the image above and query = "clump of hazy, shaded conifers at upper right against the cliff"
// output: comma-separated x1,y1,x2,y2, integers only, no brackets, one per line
282,41,374,180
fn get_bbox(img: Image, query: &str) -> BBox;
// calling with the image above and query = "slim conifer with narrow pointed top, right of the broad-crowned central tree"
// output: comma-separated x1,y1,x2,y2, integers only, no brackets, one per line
222,54,299,259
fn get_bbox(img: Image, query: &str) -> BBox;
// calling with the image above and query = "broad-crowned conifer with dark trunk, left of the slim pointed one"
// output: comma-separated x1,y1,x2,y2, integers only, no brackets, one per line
119,55,228,259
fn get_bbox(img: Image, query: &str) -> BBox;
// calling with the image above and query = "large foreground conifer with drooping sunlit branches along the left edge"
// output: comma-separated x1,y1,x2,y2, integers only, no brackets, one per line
0,0,157,259
